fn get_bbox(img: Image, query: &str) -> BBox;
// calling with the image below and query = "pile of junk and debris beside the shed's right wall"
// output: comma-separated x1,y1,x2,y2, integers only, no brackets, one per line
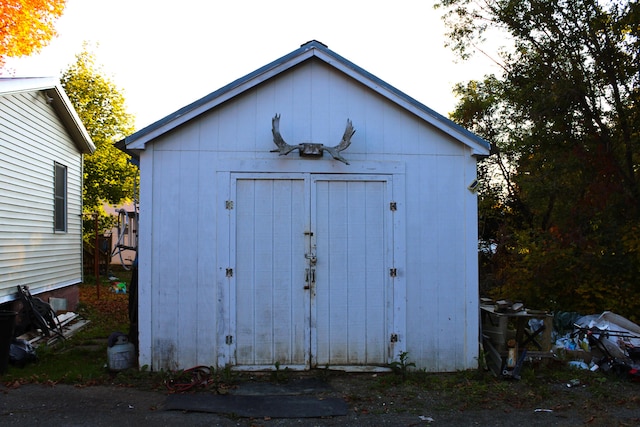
480,298,640,381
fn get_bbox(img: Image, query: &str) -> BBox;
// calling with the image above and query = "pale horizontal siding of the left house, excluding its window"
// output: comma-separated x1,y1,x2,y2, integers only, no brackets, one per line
0,92,82,302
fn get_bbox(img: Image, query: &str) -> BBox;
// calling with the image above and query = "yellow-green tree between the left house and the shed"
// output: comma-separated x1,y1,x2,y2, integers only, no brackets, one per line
61,46,139,241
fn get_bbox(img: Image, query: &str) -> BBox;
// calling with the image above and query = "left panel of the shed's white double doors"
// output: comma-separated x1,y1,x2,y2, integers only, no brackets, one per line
234,178,310,368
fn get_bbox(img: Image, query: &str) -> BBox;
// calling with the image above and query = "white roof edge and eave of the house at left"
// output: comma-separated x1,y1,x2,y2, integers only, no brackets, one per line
0,77,96,154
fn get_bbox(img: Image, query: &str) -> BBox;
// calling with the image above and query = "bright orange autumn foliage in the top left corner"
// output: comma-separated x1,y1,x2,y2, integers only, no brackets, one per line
0,0,66,68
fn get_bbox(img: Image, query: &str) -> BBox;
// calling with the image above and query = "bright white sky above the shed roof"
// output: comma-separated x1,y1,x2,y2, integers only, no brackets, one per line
3,0,504,130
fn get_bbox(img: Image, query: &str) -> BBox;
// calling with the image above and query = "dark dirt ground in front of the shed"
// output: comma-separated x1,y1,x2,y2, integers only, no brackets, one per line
0,373,640,427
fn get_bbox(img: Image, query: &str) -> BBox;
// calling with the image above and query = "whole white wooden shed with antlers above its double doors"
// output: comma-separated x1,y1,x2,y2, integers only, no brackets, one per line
119,41,489,371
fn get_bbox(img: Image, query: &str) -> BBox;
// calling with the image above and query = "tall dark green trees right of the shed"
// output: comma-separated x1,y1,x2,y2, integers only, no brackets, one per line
436,0,640,319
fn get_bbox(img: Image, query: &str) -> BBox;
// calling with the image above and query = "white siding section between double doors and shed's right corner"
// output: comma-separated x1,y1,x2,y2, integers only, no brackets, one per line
407,150,478,371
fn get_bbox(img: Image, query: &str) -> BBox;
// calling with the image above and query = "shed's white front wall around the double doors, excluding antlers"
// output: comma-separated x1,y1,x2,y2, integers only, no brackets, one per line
140,60,478,371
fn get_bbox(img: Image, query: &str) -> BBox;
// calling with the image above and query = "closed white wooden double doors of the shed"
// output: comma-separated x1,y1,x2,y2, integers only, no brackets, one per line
230,174,393,369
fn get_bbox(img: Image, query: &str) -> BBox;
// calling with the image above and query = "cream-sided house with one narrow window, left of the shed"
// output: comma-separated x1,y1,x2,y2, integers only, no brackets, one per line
0,78,95,310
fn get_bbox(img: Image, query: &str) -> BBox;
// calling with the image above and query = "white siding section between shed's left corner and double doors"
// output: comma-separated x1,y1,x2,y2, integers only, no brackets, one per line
139,146,220,369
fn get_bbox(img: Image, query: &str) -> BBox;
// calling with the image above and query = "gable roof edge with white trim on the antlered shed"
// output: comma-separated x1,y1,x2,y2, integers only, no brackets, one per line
117,40,490,155
